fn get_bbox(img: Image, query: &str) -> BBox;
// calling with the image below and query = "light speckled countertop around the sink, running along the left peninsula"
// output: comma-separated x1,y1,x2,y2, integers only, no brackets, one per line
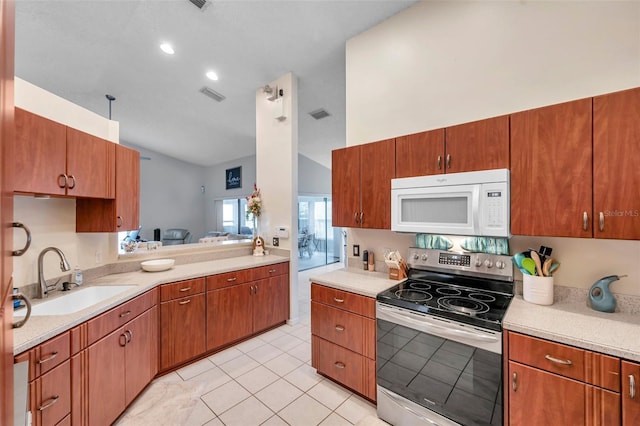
13,255,289,355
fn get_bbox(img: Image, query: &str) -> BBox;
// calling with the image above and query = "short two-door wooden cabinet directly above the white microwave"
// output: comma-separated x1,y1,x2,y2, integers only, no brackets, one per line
396,115,509,177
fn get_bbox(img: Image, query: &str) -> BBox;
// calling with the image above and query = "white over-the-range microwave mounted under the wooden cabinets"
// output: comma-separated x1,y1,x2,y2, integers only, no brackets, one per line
391,169,510,237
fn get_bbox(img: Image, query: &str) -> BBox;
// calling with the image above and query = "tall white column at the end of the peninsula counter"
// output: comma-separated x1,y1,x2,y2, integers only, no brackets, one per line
256,73,298,323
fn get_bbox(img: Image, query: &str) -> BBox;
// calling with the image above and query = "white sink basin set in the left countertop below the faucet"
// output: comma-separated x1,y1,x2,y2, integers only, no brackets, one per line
13,285,135,317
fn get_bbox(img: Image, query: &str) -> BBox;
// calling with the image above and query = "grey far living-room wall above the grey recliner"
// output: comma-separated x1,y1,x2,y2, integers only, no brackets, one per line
123,141,206,242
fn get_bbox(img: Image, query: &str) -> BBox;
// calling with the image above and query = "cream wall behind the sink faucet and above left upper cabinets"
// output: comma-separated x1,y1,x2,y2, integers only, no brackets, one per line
13,77,119,287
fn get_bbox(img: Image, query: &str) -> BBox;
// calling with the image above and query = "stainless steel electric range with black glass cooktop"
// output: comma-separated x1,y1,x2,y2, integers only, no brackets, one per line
376,248,513,426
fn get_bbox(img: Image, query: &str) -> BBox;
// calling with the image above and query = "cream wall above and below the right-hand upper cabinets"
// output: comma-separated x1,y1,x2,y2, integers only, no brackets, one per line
346,1,640,295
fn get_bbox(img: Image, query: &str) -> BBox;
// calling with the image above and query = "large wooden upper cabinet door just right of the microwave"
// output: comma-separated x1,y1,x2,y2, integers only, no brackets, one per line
511,99,592,237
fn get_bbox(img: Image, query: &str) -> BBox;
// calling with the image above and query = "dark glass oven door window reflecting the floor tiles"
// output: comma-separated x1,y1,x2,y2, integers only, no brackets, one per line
377,319,502,425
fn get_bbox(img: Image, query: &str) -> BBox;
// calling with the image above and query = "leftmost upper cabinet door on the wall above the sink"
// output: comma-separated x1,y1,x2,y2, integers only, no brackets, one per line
13,108,66,195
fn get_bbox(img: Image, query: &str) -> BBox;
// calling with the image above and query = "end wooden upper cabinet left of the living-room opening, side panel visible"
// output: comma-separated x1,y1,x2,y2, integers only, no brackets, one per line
76,144,140,232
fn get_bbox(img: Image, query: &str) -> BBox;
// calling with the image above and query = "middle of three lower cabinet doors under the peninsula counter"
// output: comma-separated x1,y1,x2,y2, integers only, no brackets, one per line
206,283,253,350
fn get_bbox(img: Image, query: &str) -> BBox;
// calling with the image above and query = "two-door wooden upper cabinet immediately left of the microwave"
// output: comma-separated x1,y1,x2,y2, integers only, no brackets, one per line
331,139,395,229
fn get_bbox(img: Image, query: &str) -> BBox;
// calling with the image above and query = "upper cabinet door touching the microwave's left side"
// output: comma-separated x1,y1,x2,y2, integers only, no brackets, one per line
360,139,396,229
